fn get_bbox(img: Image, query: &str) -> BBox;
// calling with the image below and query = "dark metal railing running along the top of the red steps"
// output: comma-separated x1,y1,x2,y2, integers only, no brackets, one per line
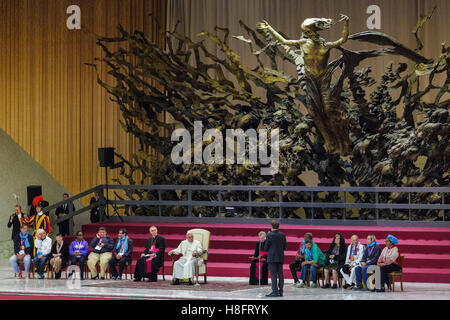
52,185,450,230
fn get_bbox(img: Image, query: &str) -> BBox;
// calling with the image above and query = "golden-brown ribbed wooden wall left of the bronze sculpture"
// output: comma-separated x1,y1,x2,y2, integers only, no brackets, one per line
0,0,166,205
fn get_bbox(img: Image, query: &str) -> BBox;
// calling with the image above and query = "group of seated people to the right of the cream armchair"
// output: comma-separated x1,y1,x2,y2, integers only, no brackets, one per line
249,231,402,292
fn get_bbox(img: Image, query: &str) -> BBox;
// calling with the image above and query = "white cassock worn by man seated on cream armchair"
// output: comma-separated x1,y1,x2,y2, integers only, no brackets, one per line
173,240,203,279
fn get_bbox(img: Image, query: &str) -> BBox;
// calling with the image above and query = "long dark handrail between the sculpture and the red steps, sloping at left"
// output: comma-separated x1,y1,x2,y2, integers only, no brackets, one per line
43,185,450,228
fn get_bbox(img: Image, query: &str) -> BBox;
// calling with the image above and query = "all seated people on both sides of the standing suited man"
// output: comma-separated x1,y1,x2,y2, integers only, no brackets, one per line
10,221,401,290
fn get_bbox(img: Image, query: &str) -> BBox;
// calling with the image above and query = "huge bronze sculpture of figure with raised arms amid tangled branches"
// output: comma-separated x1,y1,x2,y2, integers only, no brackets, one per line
90,11,450,218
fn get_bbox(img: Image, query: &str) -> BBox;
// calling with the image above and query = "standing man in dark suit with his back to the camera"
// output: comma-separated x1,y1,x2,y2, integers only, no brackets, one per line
264,220,287,297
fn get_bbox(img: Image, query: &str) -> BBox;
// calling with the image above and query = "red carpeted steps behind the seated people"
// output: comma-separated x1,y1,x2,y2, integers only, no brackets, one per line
66,222,450,283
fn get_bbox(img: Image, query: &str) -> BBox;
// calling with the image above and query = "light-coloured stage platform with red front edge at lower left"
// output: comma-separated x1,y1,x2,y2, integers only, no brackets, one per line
0,267,450,300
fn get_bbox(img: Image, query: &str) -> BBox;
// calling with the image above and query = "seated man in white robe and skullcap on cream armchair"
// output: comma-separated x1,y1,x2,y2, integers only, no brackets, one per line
169,231,203,285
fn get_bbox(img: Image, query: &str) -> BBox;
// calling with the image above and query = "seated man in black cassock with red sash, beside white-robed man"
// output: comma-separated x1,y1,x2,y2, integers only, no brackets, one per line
134,226,166,282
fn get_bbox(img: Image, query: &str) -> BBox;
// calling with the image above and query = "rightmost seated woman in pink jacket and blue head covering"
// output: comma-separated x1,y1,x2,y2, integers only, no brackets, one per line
377,235,402,292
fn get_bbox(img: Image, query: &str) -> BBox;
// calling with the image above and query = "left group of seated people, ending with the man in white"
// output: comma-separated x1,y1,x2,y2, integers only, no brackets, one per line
9,225,203,285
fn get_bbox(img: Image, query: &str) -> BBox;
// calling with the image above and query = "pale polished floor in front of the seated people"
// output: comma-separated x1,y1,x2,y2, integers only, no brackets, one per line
0,266,450,300
